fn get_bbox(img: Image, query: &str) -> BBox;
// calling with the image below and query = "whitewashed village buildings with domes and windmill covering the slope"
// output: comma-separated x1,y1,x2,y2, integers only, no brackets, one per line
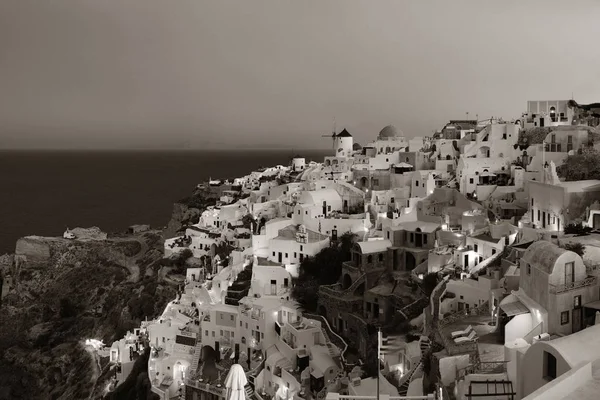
105,101,600,400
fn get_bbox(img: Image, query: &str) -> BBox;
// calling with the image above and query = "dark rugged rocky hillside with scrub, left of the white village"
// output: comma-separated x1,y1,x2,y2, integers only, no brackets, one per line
0,230,176,400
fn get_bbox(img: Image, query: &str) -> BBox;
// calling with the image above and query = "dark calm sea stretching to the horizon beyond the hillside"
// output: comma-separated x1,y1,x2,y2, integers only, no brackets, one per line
0,150,331,254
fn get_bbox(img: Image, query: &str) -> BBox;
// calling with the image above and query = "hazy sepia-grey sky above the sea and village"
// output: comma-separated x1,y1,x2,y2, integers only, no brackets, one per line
0,0,600,149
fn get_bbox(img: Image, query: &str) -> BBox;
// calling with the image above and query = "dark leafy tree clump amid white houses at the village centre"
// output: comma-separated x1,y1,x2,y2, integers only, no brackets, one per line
292,232,355,312
